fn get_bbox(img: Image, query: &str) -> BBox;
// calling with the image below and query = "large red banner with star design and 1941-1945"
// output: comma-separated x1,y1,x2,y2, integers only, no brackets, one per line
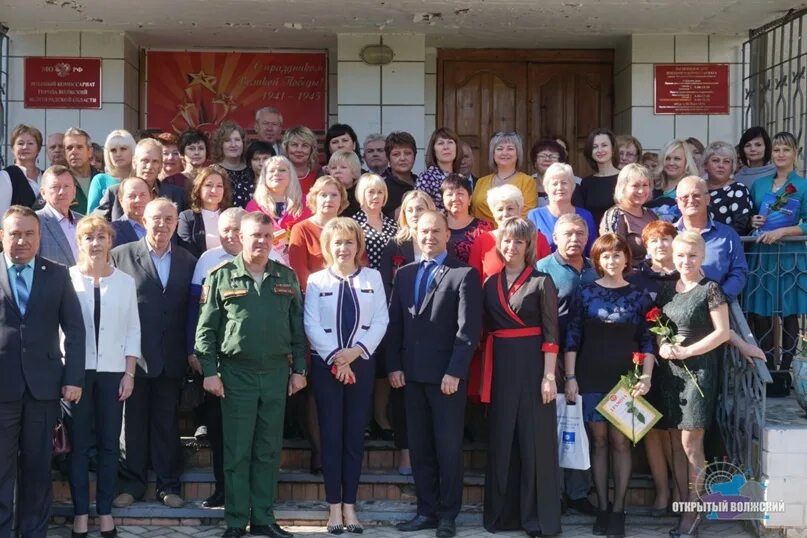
146,51,328,133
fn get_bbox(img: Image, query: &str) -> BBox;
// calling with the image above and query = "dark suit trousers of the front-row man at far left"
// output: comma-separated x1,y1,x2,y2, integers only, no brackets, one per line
0,390,59,538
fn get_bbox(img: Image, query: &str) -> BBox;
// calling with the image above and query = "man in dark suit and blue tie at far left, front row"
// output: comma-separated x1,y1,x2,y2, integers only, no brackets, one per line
0,205,84,538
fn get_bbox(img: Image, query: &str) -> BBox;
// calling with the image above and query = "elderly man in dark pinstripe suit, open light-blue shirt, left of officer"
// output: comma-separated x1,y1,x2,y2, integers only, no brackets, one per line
112,198,196,508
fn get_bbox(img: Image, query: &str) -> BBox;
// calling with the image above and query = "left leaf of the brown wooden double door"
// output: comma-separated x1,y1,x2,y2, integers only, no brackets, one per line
441,62,527,176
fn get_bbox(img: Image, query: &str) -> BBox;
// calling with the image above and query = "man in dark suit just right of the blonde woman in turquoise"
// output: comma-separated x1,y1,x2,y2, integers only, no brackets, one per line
94,138,187,221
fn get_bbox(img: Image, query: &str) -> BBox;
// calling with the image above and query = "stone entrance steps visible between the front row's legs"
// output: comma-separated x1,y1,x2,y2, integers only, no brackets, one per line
47,437,674,526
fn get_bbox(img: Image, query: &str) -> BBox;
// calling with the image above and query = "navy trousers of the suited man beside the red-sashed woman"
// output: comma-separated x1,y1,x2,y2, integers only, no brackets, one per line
404,381,466,520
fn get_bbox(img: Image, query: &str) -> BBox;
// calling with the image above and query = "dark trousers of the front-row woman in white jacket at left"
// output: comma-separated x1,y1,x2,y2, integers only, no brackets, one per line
68,370,123,516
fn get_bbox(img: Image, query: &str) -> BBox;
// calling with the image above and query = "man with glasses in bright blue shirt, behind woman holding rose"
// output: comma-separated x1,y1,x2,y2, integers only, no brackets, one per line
675,176,748,301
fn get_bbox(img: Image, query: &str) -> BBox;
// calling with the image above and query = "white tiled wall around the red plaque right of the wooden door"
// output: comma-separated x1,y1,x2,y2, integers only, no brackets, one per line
614,34,744,150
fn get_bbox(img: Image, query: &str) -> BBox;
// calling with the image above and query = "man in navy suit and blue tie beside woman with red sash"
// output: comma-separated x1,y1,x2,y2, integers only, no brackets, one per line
386,211,482,538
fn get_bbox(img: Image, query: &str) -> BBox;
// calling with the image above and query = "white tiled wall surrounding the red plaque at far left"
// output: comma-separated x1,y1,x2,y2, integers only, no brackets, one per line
8,32,140,160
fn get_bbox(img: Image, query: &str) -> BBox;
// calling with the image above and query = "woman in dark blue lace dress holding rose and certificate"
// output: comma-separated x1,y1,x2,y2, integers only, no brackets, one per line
565,233,655,536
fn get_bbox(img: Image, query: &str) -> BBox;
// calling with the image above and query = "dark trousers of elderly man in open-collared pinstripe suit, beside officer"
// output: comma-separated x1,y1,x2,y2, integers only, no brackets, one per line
118,372,182,500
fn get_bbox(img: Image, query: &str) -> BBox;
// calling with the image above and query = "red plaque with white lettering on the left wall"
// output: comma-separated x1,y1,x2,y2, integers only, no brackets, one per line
25,56,101,108
